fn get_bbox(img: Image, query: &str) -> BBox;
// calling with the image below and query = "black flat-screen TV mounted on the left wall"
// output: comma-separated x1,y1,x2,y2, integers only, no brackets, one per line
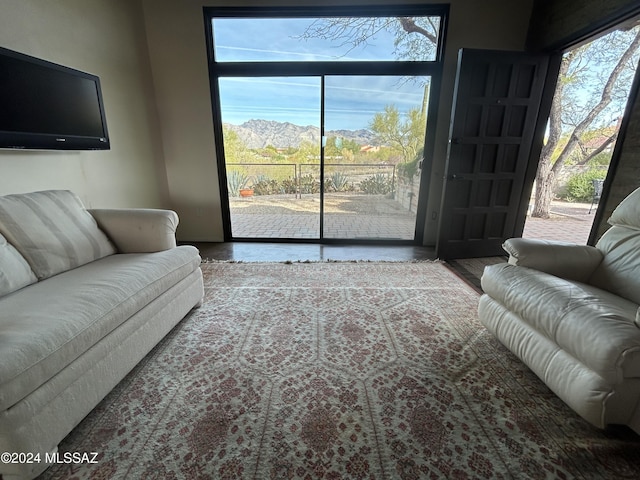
0,47,110,150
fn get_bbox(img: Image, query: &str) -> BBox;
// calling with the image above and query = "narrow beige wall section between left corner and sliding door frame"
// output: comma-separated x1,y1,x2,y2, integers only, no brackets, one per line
142,0,224,242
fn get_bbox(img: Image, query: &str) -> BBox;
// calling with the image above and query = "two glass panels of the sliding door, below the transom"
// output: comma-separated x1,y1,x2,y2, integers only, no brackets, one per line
218,75,431,242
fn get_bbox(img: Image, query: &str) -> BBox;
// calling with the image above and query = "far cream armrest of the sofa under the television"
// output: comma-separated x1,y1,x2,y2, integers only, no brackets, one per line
89,208,178,253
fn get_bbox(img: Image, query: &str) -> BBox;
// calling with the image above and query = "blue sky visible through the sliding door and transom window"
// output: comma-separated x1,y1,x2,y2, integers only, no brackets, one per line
213,19,426,130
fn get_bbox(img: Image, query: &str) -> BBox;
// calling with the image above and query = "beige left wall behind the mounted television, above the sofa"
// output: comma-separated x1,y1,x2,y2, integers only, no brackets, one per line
0,0,167,207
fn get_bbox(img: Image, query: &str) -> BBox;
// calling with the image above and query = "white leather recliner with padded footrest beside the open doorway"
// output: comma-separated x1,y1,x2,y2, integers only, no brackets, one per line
478,189,640,433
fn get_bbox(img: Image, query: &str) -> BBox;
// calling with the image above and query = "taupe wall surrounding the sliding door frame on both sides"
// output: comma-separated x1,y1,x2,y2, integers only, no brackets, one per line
142,0,533,245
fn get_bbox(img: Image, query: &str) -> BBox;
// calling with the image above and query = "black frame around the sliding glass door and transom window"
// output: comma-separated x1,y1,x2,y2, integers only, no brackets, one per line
203,4,449,244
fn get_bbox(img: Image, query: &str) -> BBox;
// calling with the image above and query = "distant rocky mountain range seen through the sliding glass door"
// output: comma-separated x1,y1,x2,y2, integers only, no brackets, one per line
224,120,376,148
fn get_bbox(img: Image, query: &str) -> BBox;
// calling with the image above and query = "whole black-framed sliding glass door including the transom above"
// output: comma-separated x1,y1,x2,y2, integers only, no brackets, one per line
205,6,446,242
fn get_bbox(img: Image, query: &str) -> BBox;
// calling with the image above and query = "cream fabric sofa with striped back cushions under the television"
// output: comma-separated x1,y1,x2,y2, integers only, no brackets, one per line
0,190,204,480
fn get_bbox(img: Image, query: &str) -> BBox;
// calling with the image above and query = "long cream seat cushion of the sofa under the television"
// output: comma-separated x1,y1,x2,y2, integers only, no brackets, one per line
0,246,200,410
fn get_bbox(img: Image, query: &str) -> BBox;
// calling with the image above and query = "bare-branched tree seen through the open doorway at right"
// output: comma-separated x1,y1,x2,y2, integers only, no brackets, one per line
532,27,640,218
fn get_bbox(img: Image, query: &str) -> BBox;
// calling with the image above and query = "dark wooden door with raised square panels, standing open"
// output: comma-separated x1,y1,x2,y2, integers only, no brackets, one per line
436,49,550,259
